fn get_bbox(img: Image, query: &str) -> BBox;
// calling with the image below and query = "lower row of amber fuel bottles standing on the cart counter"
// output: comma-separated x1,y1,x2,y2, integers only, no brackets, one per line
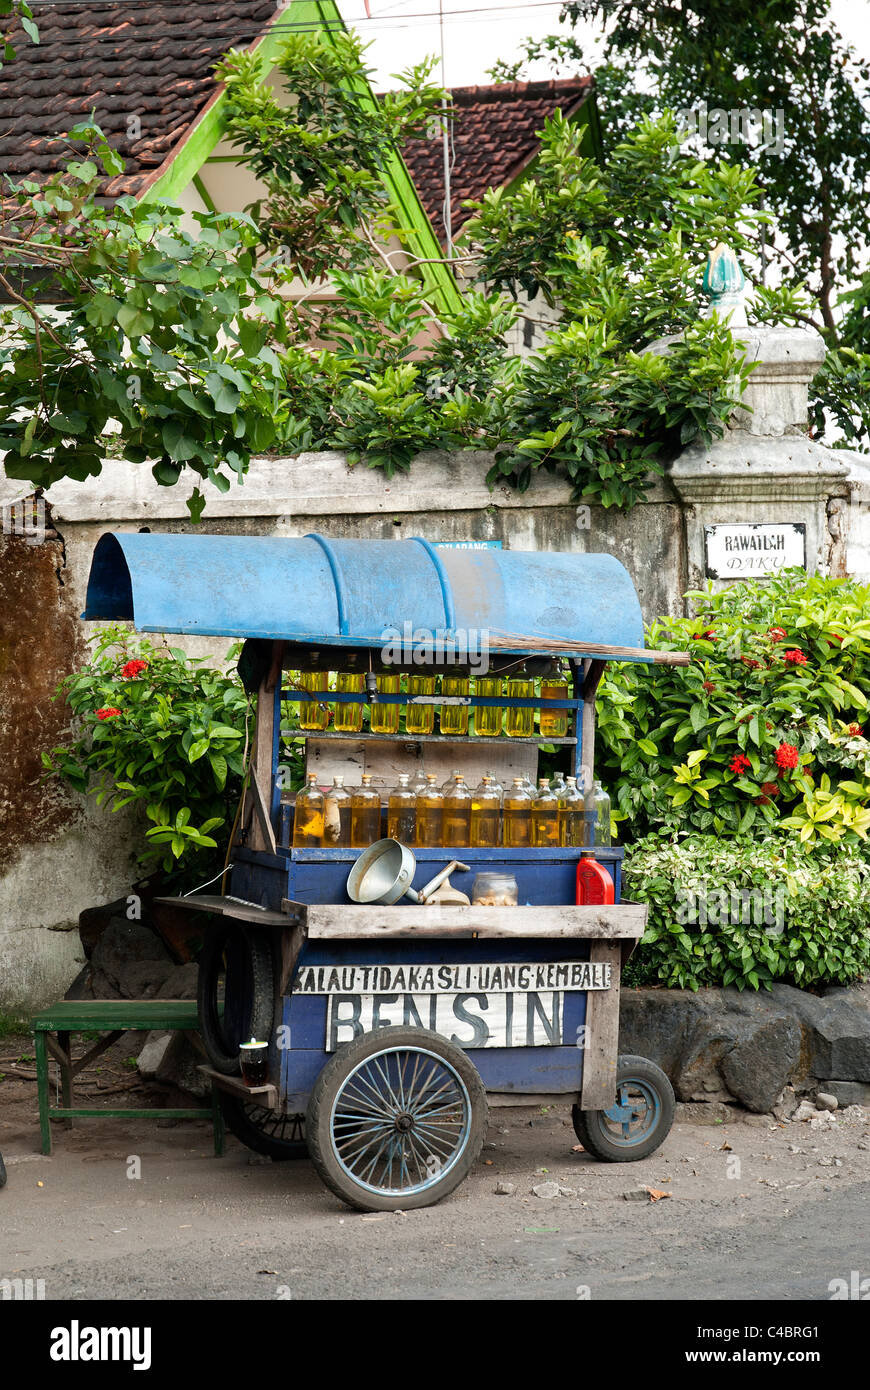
293,773,610,849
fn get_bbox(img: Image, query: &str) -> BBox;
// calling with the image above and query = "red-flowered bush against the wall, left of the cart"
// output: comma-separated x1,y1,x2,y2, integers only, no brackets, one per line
43,626,269,877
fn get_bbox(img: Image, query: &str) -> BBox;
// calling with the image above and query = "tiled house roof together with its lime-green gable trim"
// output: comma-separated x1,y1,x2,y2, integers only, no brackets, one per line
0,0,459,307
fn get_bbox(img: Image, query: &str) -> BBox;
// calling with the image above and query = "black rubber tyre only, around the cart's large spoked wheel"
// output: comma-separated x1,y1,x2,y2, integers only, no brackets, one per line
306,1027,488,1212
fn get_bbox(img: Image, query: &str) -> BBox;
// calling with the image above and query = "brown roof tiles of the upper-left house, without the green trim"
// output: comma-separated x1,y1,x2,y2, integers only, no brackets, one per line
0,0,278,197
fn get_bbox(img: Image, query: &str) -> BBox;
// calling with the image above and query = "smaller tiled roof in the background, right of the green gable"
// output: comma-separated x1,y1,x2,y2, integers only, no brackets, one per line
402,76,593,239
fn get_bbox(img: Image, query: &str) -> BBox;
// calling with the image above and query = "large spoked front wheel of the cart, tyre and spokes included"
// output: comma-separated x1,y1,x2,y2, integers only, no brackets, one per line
306,1027,488,1212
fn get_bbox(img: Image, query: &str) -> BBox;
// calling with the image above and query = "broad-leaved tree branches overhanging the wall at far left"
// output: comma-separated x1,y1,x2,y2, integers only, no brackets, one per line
0,124,291,516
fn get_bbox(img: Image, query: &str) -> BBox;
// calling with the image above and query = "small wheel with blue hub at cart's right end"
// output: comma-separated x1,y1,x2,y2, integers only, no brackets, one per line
571,1056,674,1163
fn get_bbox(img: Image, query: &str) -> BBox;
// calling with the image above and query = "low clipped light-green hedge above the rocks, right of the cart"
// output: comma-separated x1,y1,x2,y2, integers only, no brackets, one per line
624,834,870,990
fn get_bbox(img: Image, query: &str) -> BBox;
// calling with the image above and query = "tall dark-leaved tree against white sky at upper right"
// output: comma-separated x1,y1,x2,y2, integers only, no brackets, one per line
495,0,870,445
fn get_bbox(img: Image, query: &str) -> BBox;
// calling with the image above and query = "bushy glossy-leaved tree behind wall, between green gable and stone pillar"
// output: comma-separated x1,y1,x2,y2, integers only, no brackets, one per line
221,36,759,506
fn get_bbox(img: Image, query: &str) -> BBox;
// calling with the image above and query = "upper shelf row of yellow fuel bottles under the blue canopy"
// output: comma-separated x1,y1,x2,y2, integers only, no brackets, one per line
297,662,570,738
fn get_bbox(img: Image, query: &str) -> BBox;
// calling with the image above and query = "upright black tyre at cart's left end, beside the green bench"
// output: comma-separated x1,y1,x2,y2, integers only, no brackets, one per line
197,923,275,1076
